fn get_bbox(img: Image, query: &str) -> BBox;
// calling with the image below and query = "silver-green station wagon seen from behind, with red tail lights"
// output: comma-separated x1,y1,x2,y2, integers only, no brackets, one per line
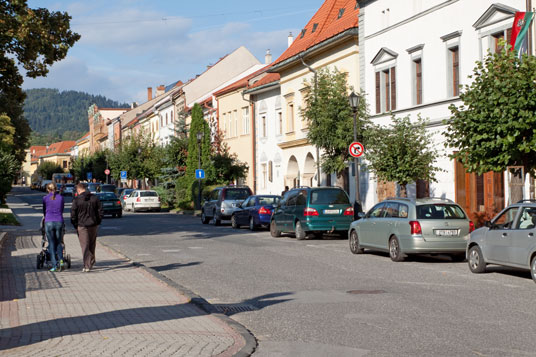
348,198,474,262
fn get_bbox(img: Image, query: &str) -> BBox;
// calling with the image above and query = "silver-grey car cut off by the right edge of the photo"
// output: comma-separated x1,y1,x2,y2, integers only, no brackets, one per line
467,201,536,282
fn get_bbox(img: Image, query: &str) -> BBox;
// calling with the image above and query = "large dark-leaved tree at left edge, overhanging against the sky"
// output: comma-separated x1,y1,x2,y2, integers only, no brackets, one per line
0,0,80,163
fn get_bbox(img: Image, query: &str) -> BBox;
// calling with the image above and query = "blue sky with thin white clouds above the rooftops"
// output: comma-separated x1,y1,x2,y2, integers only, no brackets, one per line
23,0,324,103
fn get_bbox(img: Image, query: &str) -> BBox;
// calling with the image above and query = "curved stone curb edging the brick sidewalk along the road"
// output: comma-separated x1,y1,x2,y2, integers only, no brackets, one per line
97,240,257,357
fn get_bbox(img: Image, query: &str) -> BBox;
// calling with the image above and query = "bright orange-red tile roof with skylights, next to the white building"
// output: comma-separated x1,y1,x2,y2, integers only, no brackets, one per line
274,0,359,65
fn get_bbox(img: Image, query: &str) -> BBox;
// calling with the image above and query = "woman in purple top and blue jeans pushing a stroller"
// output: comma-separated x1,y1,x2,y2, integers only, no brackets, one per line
43,183,64,271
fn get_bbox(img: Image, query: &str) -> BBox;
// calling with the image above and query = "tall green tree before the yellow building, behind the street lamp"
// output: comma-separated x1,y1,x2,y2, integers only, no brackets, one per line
301,68,368,185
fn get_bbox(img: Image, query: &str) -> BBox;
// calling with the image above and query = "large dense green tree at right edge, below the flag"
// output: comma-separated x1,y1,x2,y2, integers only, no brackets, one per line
445,46,536,174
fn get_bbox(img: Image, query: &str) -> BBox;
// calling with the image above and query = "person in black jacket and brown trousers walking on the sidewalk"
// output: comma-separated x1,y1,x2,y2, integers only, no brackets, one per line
71,183,103,272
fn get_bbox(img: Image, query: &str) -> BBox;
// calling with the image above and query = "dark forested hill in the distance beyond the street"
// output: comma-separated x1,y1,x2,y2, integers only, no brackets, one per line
24,88,128,145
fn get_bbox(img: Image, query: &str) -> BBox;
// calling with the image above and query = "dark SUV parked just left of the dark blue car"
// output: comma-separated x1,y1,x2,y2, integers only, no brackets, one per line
201,186,252,226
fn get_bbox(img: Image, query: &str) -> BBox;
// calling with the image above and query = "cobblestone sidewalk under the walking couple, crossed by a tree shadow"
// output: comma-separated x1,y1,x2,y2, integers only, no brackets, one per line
0,227,245,356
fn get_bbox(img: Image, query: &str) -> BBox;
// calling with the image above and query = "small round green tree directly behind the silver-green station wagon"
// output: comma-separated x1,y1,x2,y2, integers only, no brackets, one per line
365,116,441,197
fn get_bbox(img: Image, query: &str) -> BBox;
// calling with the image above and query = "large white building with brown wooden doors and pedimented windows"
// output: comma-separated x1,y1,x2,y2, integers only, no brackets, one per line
358,0,525,217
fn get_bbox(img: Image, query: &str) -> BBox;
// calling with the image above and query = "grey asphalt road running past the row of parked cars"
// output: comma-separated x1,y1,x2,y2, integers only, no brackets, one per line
14,188,536,357
